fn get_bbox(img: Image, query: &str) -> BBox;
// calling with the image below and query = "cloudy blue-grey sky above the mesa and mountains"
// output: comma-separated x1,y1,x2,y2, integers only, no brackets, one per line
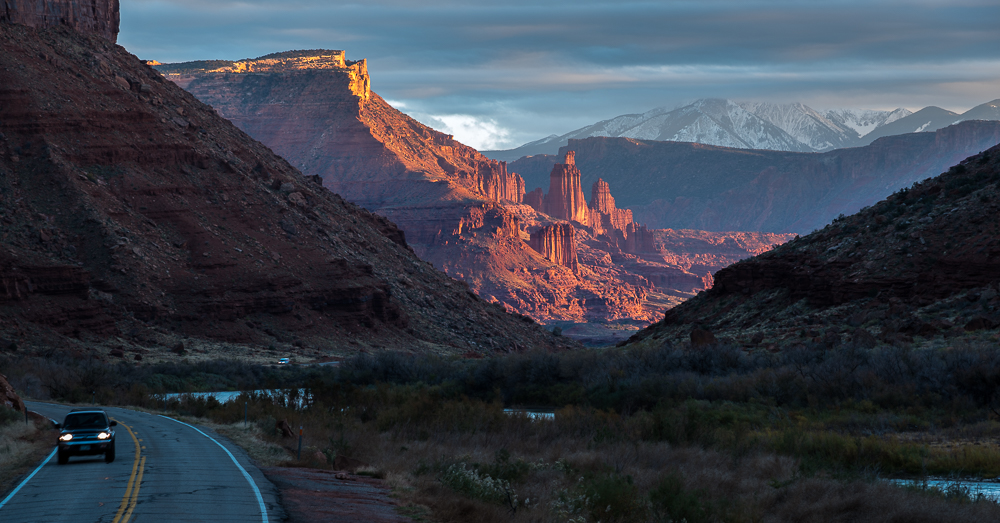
118,0,1000,150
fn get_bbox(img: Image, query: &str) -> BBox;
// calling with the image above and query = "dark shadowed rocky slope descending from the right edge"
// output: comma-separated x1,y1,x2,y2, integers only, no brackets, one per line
631,141,1000,347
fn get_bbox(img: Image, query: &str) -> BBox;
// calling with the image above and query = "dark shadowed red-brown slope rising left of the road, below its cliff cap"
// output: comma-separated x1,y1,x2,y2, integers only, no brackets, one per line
0,23,563,359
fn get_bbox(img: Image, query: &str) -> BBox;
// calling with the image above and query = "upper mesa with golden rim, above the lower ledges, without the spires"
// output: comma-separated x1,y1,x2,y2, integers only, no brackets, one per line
156,50,524,209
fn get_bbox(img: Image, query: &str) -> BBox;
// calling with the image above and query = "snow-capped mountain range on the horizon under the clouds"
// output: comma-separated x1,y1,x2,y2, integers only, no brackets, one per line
483,98,1000,162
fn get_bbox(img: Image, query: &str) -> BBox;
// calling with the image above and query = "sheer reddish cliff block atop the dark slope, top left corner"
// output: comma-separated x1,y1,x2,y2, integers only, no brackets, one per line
0,0,120,42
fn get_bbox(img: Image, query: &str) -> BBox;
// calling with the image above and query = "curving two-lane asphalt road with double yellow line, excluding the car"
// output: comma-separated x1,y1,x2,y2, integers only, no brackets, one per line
0,402,284,523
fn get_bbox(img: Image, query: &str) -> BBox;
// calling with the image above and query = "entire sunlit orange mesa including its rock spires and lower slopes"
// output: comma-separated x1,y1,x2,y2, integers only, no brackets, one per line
156,50,796,322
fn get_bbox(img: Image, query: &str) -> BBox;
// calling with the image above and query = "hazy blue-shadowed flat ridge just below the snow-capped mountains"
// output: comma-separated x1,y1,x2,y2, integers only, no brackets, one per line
509,120,1000,234
